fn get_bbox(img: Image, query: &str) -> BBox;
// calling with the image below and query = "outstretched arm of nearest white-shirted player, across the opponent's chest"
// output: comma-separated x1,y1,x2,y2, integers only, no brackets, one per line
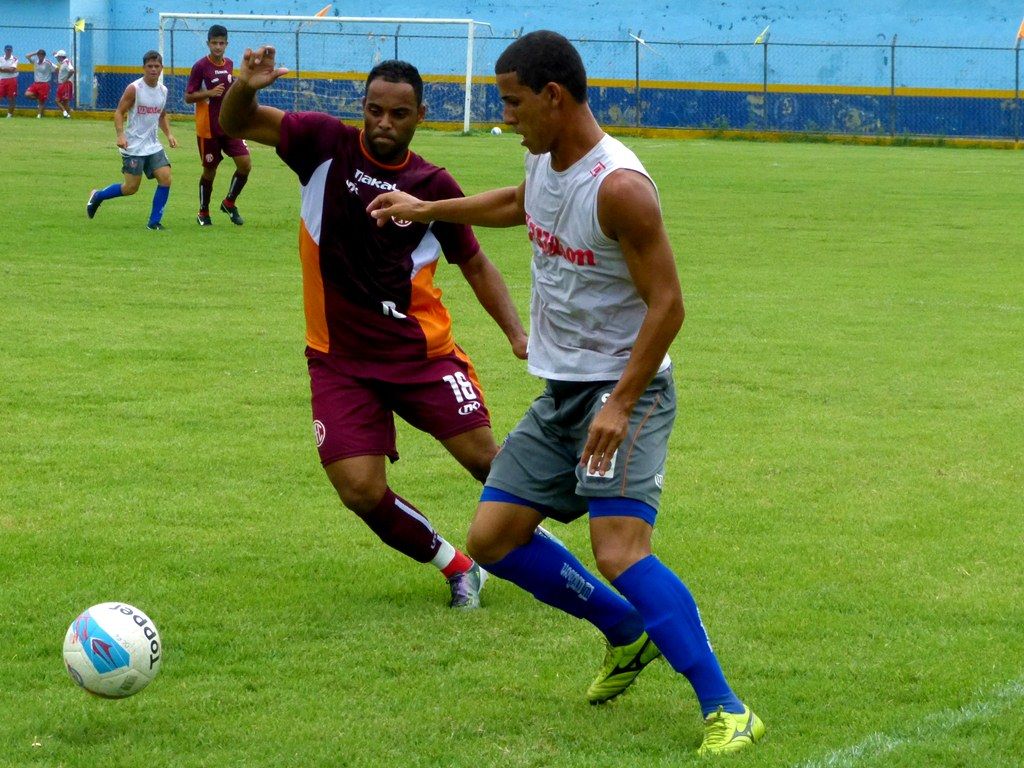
367,182,526,226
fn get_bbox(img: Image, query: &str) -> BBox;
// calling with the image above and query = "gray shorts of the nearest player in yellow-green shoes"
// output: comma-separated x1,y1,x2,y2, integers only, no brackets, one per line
486,369,676,522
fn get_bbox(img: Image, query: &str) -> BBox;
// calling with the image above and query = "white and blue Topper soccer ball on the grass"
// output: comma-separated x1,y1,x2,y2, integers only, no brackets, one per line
65,603,163,698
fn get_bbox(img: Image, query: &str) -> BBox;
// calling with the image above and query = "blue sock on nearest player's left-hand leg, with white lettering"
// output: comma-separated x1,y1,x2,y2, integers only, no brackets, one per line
481,534,643,645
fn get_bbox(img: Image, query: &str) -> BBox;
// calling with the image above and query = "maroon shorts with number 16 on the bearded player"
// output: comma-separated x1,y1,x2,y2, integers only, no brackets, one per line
306,348,490,466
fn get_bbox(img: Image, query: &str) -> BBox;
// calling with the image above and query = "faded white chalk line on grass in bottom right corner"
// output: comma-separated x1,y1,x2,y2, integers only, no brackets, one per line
801,680,1024,768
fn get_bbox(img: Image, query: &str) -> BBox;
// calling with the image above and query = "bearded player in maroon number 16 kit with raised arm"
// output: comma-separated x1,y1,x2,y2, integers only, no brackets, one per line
220,46,526,608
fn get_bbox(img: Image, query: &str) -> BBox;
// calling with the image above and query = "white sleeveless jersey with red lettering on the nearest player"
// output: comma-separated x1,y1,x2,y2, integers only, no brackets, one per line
525,136,670,381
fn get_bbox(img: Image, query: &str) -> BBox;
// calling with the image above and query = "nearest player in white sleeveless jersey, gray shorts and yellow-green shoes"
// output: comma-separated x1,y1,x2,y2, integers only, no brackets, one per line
370,32,765,754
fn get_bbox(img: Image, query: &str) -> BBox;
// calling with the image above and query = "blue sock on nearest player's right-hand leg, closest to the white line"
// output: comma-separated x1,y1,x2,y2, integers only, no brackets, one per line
612,555,743,717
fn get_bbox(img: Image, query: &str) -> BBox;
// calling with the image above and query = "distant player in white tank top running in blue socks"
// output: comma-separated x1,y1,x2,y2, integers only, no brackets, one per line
85,50,178,230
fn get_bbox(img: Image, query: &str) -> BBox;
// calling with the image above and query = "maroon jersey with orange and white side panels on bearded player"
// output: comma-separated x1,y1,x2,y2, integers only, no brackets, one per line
278,113,479,360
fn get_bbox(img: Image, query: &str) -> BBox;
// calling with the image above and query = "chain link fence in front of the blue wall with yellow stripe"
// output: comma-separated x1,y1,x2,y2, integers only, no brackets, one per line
4,19,1022,140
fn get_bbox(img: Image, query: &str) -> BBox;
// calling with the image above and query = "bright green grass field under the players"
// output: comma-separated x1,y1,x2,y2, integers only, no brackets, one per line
0,119,1024,768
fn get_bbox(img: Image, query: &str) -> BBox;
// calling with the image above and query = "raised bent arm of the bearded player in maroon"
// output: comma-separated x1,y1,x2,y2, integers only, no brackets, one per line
220,45,288,146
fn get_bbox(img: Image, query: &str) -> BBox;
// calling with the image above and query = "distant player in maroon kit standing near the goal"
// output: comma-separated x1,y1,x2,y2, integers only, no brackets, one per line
185,24,252,226
